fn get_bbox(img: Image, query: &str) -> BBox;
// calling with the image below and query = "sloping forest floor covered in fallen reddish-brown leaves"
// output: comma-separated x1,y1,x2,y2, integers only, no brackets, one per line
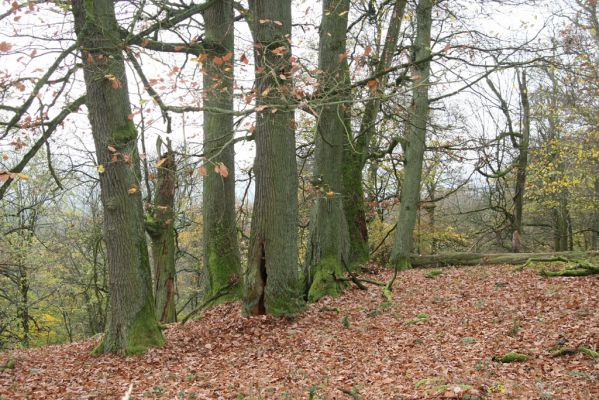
0,266,599,400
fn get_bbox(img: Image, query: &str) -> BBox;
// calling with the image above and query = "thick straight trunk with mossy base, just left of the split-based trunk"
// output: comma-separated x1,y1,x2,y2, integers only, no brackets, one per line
202,0,241,299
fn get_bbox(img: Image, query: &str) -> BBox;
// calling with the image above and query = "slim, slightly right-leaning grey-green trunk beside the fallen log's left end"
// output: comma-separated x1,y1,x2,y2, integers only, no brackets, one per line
391,0,433,269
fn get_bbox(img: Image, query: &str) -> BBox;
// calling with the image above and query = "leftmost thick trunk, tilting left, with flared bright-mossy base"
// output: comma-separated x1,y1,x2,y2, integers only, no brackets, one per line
72,0,164,354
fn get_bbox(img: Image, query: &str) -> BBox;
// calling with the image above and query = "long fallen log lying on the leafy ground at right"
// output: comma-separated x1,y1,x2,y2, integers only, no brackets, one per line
410,251,599,267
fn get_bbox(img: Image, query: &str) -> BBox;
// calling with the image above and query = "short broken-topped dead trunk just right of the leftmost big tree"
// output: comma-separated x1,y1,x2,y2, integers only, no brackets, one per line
146,148,177,323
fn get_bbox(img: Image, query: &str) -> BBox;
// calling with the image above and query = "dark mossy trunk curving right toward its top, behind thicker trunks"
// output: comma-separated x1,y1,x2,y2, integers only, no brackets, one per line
343,0,407,264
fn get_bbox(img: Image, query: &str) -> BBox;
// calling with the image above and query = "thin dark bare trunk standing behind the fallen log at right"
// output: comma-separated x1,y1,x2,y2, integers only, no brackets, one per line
512,71,530,253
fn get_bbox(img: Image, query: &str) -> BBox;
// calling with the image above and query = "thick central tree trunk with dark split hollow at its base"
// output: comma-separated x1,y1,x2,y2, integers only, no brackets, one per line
244,0,304,315
